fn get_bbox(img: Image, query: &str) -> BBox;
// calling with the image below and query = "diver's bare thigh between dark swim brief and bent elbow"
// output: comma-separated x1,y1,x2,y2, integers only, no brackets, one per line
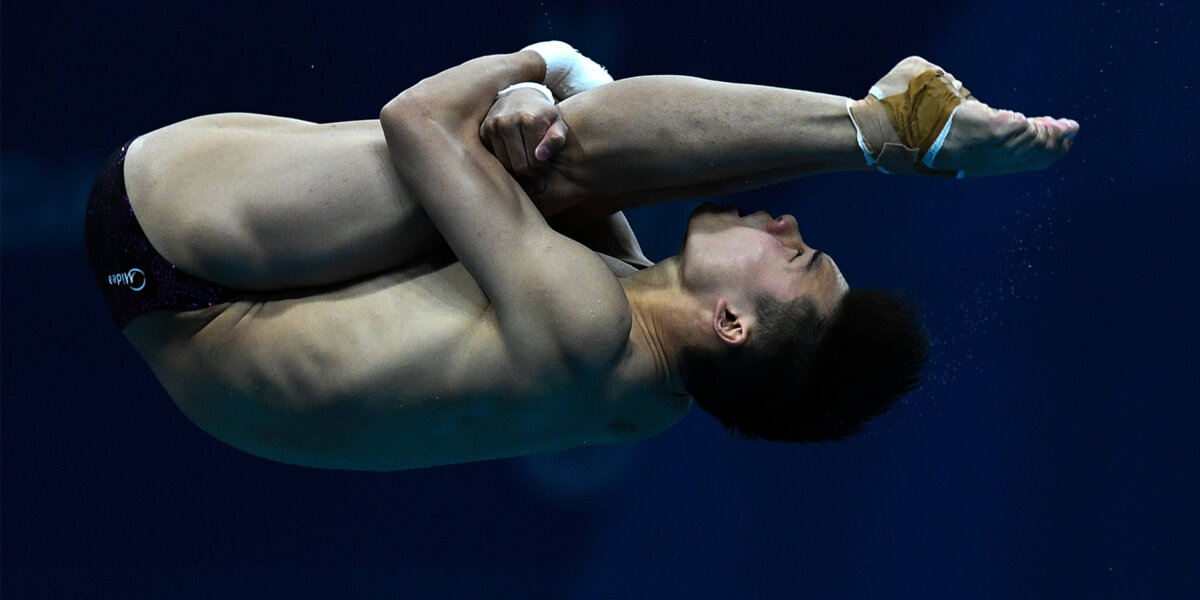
125,114,443,290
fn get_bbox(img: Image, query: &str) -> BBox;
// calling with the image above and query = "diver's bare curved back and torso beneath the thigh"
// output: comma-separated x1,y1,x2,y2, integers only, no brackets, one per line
125,114,688,470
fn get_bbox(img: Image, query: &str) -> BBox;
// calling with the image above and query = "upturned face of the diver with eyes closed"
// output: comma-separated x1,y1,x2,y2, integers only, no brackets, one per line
679,203,850,314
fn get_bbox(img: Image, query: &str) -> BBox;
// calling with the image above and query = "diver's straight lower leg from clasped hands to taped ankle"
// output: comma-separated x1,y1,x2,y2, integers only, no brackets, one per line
535,76,865,210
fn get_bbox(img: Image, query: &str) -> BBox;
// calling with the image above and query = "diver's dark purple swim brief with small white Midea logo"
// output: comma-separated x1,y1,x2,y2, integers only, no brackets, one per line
84,139,244,329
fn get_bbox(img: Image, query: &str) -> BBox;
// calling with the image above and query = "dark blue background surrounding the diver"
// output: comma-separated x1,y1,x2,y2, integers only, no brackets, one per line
0,0,1200,599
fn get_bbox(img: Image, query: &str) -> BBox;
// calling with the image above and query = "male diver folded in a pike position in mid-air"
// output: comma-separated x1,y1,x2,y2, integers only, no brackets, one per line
86,42,1079,470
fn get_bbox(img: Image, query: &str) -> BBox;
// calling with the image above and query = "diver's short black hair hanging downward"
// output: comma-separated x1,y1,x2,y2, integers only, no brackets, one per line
682,289,928,442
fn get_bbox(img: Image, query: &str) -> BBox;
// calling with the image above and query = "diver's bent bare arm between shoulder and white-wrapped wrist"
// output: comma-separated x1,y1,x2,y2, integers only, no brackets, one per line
379,52,583,312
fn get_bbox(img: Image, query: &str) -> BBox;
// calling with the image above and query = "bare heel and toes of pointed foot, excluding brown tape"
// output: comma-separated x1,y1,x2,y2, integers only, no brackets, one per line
871,56,1079,176
